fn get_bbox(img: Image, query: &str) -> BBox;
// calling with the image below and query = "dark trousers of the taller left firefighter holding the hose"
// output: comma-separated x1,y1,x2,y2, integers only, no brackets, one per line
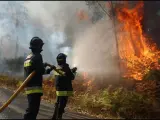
24,93,42,120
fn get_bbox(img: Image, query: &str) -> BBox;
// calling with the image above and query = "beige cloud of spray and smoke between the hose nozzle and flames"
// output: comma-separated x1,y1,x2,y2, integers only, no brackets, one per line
73,18,119,77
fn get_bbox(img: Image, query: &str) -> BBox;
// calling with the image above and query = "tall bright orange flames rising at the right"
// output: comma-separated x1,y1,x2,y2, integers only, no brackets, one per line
117,2,160,80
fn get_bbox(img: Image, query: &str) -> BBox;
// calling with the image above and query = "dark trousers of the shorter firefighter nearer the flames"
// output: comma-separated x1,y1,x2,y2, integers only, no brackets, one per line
52,96,68,120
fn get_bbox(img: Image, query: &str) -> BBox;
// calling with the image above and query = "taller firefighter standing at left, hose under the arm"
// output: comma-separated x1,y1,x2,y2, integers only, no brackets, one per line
24,37,51,120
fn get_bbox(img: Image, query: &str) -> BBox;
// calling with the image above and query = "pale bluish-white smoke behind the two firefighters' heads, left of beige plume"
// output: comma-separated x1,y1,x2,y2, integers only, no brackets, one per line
0,1,88,64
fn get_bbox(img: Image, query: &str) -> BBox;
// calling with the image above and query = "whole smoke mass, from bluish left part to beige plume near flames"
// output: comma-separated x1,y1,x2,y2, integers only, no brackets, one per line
0,1,120,80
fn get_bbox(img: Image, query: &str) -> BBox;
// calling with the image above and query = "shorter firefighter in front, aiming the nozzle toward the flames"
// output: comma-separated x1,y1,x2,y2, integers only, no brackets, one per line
47,53,77,120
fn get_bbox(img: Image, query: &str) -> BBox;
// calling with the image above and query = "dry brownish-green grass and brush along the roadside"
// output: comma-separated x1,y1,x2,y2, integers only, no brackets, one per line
0,75,159,118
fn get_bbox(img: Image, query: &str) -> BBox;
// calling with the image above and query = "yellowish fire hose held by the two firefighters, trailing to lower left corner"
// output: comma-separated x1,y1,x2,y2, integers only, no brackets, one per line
0,64,64,113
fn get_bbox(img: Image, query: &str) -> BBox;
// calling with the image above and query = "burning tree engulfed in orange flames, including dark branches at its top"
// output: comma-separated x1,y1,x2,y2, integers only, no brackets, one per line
87,1,160,80
